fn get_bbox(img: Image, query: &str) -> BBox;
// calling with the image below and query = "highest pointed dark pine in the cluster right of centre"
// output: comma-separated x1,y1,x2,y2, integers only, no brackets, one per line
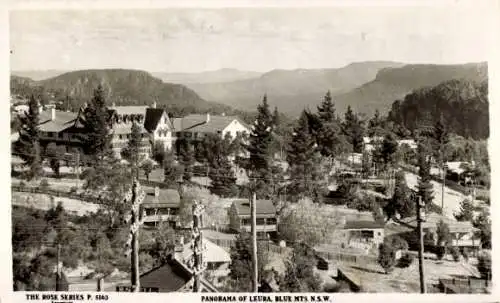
316,91,346,160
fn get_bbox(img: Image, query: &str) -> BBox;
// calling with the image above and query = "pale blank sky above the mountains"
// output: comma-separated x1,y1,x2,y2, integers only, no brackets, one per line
9,6,491,73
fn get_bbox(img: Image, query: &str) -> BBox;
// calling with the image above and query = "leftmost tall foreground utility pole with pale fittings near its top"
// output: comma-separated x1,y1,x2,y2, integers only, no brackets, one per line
125,179,146,292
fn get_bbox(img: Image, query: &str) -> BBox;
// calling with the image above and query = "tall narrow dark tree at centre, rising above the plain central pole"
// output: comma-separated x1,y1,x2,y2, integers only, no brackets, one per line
247,95,274,198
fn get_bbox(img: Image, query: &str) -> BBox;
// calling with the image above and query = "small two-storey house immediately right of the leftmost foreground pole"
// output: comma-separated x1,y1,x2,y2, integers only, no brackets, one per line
141,187,180,227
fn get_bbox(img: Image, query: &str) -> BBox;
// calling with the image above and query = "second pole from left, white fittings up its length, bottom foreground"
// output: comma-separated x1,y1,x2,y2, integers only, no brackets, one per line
190,201,207,292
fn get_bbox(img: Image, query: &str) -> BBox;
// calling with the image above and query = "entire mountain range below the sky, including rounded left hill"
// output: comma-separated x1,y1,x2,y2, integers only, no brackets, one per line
11,61,488,116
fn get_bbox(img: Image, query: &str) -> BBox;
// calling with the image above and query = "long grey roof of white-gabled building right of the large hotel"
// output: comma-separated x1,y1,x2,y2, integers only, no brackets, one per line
173,115,247,133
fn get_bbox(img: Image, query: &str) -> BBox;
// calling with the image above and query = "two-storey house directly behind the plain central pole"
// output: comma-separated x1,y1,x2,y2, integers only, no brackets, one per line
229,199,278,237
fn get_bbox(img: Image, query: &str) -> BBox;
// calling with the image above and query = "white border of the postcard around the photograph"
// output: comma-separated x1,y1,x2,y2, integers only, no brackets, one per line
0,0,500,303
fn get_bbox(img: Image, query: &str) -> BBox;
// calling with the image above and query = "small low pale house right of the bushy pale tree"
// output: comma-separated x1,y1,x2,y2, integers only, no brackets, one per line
341,220,384,251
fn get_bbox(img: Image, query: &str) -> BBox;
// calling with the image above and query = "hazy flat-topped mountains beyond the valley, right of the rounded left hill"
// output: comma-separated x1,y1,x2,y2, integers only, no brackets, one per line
182,62,488,116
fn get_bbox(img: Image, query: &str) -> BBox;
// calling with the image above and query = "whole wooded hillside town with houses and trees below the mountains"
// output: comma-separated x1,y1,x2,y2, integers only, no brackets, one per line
11,82,491,293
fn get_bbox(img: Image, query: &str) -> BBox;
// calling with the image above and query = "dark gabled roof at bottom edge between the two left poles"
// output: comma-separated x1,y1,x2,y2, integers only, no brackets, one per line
141,260,192,292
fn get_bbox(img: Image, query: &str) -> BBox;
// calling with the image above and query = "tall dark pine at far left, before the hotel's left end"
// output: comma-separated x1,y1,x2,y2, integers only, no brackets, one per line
14,95,42,179
